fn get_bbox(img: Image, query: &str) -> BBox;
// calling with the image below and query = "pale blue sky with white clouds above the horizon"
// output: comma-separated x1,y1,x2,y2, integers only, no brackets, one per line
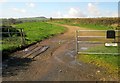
0,0,118,18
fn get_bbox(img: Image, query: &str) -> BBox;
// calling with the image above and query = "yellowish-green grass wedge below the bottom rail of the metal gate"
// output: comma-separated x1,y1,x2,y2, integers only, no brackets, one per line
77,55,120,76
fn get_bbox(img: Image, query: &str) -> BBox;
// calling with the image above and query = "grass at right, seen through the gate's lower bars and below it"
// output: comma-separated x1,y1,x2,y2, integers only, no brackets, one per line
77,47,120,74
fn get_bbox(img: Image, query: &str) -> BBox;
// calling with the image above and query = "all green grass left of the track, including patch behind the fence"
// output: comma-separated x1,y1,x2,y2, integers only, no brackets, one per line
0,22,67,51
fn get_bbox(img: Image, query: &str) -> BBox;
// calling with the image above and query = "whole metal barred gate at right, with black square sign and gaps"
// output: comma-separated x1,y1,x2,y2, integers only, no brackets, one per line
76,30,120,55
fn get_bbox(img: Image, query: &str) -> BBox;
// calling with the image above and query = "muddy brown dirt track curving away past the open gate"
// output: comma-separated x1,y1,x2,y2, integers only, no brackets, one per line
3,25,118,81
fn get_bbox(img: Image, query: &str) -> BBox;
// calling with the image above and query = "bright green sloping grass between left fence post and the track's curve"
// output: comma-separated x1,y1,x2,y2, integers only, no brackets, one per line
15,22,66,44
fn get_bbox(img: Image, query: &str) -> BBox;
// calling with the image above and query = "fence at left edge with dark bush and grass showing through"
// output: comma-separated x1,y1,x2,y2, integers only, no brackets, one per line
0,27,26,49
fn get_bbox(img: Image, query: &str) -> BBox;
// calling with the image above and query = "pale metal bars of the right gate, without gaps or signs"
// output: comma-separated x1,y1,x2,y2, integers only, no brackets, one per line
76,30,120,55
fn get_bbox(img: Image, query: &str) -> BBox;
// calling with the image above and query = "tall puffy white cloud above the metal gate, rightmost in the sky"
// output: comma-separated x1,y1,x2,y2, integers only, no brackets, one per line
87,3,101,16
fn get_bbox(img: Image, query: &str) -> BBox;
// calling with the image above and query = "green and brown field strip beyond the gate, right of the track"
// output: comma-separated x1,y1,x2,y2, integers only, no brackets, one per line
54,18,118,30
